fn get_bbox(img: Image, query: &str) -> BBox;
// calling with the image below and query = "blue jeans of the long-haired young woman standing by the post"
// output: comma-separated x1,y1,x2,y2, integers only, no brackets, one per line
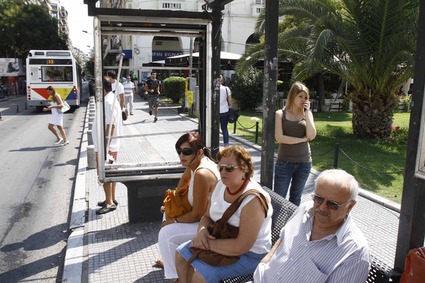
274,160,312,205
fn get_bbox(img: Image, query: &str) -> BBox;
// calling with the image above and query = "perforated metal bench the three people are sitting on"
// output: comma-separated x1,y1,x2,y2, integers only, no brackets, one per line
222,187,400,283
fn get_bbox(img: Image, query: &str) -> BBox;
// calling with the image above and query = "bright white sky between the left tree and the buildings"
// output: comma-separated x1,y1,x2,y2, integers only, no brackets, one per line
57,0,94,53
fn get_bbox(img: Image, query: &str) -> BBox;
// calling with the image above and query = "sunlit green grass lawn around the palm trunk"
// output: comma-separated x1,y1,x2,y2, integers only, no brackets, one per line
229,111,410,203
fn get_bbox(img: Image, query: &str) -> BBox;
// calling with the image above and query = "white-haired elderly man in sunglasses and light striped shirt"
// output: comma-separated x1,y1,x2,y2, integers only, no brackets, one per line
254,169,370,283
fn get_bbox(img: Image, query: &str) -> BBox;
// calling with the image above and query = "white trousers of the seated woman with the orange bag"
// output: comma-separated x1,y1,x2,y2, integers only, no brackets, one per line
158,222,199,279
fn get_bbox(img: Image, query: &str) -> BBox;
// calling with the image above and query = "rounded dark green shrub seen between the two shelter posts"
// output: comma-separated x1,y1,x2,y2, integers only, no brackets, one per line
232,67,264,110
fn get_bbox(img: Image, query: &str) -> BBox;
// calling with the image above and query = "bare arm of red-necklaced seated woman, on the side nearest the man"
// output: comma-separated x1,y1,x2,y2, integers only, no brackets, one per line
208,197,264,256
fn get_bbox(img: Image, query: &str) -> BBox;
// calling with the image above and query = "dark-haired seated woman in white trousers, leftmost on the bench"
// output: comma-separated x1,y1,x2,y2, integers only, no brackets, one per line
156,133,220,279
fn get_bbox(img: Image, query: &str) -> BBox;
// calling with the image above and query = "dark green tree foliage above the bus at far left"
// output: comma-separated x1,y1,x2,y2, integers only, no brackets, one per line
0,0,68,59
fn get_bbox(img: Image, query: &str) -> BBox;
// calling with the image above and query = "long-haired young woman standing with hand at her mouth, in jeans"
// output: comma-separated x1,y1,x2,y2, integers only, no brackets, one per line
274,82,316,205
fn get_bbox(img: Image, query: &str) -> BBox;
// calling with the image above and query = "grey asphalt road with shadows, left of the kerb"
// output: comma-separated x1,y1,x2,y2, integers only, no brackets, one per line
0,86,88,282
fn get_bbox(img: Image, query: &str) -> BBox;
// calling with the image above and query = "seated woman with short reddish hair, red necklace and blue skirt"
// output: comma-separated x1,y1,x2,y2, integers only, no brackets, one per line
176,146,273,283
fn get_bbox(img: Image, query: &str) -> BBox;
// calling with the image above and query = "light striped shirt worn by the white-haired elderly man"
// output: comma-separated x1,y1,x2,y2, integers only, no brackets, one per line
254,201,370,283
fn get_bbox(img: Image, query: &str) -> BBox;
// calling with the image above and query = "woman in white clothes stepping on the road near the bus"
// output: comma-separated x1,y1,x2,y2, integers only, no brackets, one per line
43,86,69,145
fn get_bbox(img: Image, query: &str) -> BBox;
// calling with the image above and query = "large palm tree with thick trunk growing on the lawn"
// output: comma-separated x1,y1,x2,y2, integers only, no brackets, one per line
238,0,419,138
